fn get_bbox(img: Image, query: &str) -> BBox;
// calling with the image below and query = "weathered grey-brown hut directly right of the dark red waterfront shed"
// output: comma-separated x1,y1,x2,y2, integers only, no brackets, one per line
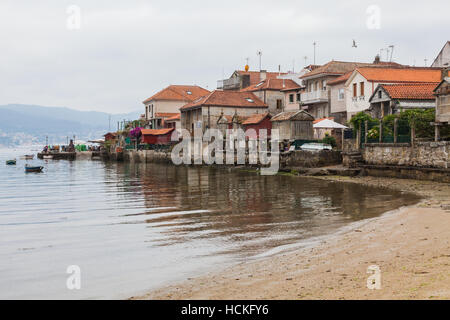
271,110,314,141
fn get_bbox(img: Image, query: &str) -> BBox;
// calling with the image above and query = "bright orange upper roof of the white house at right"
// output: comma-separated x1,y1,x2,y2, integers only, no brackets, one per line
357,67,441,83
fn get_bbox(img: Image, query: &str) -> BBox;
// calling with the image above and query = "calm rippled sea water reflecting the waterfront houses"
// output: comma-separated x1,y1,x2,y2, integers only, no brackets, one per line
0,149,418,299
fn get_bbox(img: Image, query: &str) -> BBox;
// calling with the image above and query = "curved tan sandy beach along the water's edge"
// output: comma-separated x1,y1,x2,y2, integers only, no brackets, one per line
130,176,450,300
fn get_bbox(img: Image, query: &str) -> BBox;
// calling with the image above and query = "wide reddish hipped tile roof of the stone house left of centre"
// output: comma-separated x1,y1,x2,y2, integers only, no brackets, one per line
180,90,267,110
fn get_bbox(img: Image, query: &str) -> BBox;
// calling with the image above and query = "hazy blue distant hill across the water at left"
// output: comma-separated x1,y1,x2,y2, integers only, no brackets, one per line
0,104,142,146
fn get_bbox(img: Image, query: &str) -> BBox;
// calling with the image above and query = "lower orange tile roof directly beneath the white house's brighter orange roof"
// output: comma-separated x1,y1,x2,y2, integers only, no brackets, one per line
381,83,436,100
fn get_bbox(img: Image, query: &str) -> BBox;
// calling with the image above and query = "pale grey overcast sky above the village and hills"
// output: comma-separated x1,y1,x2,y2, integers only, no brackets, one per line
0,0,450,113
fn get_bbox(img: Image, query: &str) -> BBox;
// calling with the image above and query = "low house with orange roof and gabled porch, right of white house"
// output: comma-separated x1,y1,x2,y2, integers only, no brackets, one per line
368,83,436,119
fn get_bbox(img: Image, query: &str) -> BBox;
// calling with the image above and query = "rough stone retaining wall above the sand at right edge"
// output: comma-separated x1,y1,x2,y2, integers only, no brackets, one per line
362,141,450,169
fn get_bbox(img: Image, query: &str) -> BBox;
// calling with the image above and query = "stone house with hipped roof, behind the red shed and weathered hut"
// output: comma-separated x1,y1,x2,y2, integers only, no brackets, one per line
242,79,301,114
